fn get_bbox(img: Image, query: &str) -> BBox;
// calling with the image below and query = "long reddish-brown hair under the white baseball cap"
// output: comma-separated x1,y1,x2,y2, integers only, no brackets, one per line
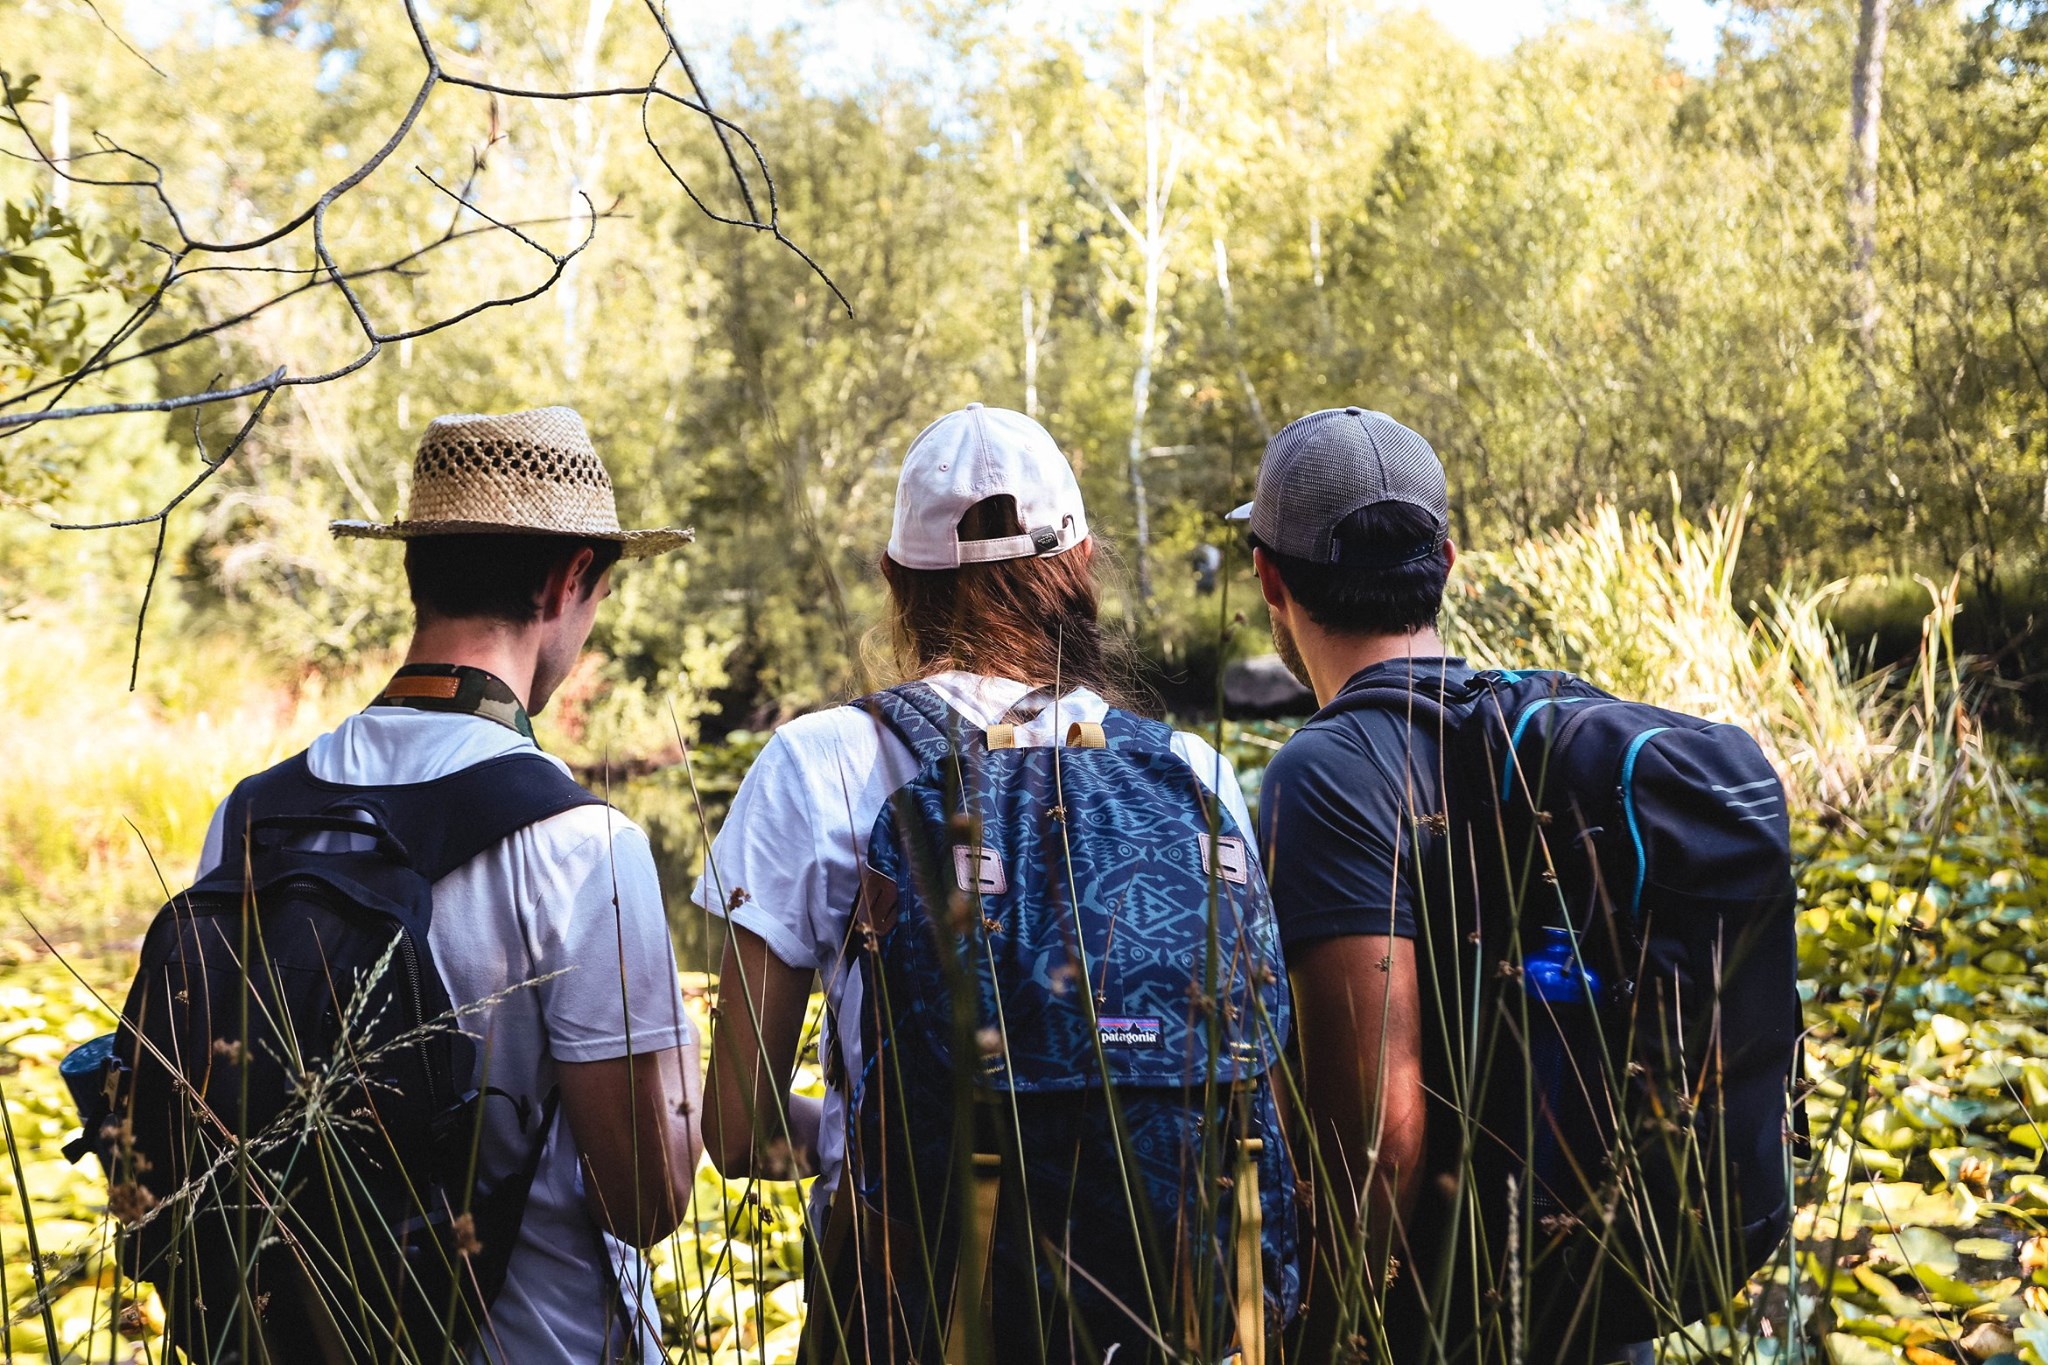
883,495,1133,702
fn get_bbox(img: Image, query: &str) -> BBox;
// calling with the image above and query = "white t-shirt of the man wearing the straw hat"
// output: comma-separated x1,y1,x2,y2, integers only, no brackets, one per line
199,706,694,1365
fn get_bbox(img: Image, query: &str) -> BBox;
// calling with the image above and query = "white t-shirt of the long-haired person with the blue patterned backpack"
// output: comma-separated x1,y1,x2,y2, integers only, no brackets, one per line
692,673,1251,1228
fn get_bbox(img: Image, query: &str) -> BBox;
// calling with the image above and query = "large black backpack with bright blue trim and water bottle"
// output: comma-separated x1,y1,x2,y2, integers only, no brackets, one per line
1321,669,1804,1361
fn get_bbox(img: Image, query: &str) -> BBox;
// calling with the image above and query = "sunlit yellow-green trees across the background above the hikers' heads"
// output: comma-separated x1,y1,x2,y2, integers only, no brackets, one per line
0,0,2048,722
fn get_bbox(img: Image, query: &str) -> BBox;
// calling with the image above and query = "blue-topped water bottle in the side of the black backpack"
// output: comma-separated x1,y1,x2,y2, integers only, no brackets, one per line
1522,925,1618,1218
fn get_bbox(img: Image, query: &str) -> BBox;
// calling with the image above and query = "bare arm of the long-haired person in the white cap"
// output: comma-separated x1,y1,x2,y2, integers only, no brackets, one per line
705,925,819,1181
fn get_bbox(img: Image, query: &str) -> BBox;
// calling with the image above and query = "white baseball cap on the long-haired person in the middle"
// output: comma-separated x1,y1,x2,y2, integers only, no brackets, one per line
889,403,1087,569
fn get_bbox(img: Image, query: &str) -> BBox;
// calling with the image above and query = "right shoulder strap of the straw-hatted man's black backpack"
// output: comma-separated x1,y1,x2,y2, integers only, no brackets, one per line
379,749,606,882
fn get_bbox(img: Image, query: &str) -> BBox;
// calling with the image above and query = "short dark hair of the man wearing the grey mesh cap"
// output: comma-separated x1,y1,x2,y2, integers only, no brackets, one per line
1253,501,1450,634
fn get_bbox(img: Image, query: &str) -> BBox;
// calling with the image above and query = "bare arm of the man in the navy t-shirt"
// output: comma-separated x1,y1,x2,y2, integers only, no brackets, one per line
1288,935,1427,1332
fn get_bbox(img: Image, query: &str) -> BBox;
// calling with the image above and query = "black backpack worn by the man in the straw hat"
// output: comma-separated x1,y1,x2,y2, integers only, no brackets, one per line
68,753,602,1363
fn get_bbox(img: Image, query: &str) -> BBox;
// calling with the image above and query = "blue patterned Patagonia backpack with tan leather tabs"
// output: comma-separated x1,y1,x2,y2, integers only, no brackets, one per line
813,684,1300,1365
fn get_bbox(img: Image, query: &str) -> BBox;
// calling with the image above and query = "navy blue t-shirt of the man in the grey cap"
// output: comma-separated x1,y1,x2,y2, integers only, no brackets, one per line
1260,659,1473,950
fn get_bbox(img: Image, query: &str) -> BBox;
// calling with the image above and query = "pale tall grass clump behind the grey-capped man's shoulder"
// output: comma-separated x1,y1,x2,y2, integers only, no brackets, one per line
1446,493,2005,825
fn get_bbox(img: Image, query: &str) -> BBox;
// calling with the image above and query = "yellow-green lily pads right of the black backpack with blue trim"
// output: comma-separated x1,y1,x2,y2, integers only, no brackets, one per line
1777,788,2048,1365
